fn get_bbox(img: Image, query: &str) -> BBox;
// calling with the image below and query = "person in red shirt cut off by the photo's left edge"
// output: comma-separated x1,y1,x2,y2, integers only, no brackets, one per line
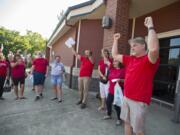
0,53,8,100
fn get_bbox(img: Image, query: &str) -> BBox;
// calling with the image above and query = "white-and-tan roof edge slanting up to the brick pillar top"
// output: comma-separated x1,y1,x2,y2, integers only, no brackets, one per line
47,0,105,47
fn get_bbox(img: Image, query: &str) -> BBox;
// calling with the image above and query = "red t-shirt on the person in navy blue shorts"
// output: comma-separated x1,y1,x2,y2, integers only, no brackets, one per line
32,58,49,74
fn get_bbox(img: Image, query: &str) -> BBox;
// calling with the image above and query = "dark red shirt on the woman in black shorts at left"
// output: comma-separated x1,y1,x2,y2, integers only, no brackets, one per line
11,62,25,78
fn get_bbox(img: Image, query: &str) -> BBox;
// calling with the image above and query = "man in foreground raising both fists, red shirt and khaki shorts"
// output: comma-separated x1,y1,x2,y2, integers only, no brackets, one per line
112,17,160,135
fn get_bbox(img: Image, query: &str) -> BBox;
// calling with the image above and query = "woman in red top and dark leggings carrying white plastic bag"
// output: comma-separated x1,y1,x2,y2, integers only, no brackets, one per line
104,60,125,125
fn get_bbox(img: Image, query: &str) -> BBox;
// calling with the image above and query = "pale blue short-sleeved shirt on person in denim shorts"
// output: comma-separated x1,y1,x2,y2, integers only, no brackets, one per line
51,61,65,76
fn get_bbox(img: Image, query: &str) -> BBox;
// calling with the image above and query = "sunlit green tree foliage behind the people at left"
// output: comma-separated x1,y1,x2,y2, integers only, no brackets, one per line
0,27,47,56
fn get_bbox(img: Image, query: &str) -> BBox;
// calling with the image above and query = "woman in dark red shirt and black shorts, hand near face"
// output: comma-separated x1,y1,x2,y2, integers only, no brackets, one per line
11,54,26,100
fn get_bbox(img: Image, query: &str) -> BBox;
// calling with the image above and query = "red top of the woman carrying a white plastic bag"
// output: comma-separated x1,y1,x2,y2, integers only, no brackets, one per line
108,68,125,95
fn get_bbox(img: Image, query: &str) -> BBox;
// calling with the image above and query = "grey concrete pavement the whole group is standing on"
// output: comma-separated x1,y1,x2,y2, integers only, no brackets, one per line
0,79,180,135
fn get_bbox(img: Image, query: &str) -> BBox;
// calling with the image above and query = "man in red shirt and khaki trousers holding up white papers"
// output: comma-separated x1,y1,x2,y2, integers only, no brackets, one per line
71,47,94,109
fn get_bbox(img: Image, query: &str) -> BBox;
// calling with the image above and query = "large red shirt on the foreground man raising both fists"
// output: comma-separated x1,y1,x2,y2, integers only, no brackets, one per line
123,55,160,104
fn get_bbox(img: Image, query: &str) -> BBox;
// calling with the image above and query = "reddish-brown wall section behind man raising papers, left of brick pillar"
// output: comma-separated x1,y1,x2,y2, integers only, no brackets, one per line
78,20,103,69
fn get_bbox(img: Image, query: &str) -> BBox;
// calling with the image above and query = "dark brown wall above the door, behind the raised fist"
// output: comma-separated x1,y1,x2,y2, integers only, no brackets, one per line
135,1,180,36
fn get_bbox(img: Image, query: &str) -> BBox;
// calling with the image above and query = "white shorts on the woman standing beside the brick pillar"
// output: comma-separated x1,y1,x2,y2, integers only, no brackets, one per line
99,82,109,98
